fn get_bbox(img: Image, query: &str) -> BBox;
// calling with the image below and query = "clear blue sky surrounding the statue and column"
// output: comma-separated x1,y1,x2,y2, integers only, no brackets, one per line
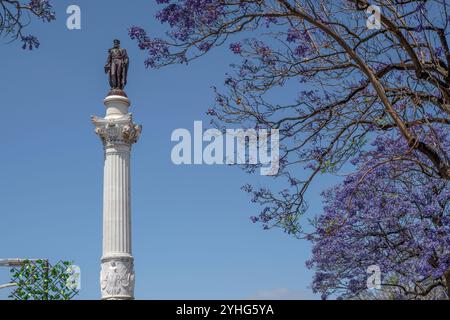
0,0,338,299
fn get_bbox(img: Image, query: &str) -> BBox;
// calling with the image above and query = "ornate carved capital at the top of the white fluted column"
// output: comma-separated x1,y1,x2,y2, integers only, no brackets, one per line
92,114,142,146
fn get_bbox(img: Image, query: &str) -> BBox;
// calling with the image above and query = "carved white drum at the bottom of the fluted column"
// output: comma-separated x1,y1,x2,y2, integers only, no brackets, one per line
100,258,134,299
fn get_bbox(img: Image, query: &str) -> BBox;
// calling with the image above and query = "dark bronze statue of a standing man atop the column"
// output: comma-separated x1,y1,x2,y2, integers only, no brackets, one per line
105,39,130,95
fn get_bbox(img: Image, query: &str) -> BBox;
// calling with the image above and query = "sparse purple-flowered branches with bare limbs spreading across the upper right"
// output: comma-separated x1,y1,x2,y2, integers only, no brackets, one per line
129,0,450,235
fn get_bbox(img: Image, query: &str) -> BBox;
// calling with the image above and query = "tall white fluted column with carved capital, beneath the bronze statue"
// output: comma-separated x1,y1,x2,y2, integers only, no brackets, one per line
92,95,142,300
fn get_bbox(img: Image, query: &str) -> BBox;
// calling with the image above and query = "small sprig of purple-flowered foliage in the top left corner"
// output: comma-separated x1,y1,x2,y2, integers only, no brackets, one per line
0,0,55,50
